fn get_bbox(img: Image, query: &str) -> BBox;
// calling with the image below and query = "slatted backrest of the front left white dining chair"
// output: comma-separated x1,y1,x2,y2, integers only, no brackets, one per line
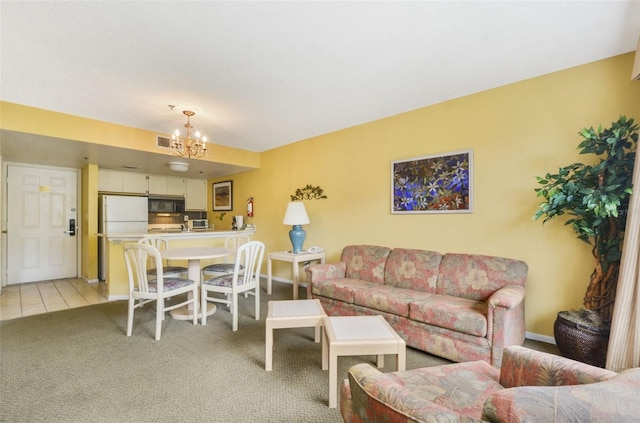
124,242,164,295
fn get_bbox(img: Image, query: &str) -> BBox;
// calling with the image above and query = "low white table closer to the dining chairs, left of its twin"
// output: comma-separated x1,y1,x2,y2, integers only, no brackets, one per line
264,300,326,371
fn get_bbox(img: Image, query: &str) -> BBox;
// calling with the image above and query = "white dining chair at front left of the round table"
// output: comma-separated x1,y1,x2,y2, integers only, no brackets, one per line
124,243,199,341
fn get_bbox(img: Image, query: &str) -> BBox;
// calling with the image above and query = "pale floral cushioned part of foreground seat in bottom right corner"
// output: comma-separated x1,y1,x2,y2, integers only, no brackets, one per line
483,368,640,423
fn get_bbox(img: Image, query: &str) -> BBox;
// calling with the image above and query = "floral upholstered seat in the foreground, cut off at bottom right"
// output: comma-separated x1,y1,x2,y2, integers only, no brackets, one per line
340,346,640,423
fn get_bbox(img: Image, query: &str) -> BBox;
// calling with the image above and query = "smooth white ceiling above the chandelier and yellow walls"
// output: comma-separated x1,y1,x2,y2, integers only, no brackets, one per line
0,1,640,176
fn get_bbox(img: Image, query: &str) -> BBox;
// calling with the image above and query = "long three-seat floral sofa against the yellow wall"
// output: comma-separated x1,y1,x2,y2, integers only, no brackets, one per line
306,245,528,367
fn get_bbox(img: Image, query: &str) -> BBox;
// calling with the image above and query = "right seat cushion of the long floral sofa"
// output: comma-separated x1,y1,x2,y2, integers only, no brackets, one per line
409,295,487,337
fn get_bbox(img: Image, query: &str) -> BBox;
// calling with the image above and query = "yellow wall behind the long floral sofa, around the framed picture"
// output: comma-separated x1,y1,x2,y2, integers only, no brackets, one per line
218,53,640,336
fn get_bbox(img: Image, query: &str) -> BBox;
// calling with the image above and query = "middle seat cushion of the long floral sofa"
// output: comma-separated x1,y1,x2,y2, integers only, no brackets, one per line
352,285,432,317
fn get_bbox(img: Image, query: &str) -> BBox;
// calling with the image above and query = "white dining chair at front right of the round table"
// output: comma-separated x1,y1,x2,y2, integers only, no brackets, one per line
200,241,264,332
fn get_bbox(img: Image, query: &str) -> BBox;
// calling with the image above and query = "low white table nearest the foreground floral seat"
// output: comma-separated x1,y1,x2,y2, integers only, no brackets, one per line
322,316,407,408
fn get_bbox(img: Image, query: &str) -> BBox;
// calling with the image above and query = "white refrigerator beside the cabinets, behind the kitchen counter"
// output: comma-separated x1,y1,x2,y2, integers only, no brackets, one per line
98,195,149,281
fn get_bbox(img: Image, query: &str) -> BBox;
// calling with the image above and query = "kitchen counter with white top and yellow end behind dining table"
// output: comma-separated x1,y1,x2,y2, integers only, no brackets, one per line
98,229,255,300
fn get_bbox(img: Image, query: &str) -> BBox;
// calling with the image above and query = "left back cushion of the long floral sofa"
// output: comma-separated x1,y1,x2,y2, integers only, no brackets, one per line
340,245,391,285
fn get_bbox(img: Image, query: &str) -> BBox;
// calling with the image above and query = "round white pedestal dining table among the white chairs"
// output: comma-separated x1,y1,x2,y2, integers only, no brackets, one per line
160,247,233,320
